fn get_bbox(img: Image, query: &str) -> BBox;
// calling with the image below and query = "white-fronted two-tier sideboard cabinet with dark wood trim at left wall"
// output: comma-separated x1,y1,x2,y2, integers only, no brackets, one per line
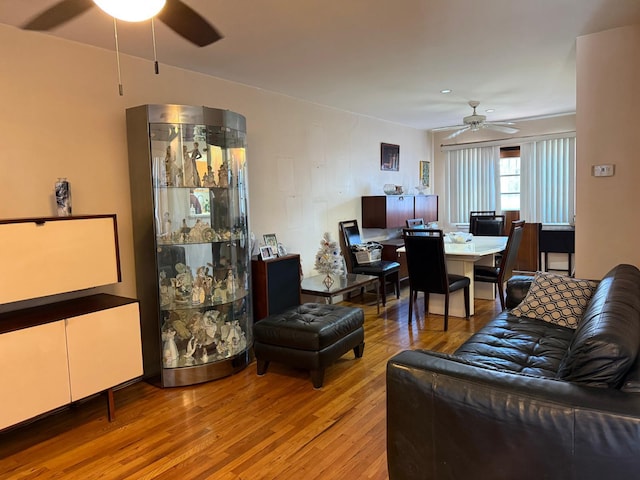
0,215,143,429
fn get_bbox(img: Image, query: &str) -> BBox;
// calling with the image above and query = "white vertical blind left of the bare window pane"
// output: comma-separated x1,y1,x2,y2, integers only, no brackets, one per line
445,146,500,224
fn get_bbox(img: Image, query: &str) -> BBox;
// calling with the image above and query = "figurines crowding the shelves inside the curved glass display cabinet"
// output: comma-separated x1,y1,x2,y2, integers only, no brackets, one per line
154,137,249,368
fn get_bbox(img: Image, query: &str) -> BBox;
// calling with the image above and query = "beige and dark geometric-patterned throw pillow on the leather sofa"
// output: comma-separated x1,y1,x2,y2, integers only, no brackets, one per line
511,272,598,328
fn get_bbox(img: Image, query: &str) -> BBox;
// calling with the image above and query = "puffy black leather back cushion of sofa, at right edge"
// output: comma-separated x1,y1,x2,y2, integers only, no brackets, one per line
558,265,640,388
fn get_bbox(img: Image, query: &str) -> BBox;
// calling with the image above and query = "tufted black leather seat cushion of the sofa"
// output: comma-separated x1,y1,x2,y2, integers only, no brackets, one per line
454,312,574,378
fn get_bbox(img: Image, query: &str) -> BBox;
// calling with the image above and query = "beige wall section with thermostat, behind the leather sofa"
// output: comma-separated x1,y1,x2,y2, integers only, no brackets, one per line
576,25,640,278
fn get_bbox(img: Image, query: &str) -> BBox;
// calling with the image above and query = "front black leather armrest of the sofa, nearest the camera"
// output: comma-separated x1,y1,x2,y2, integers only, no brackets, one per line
387,351,640,480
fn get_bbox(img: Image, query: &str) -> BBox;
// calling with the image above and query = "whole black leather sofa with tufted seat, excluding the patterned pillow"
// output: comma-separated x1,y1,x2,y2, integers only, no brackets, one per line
387,265,640,480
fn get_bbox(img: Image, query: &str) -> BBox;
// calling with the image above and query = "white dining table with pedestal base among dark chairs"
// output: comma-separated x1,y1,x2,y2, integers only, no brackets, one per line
397,234,509,317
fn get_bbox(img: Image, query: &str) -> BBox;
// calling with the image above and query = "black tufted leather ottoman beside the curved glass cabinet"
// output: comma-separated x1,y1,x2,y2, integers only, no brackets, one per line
253,303,364,388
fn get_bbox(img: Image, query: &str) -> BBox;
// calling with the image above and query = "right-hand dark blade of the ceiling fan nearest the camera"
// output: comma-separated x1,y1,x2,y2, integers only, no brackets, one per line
157,0,222,47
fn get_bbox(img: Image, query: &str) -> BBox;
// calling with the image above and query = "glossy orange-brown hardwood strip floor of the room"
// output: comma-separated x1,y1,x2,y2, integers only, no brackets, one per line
0,287,499,480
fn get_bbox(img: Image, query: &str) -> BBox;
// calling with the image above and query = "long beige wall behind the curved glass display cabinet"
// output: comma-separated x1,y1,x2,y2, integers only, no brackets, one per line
0,25,431,302
